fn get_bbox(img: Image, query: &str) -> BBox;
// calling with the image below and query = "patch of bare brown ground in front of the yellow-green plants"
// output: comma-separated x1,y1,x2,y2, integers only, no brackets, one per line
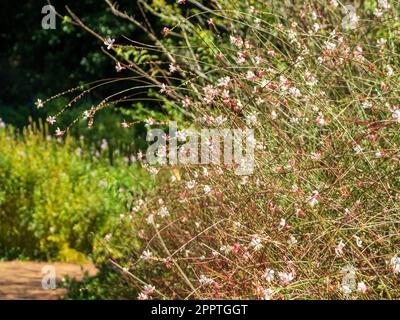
0,261,97,300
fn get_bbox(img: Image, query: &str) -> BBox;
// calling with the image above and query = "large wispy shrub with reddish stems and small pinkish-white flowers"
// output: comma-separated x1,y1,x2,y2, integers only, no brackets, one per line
51,0,400,299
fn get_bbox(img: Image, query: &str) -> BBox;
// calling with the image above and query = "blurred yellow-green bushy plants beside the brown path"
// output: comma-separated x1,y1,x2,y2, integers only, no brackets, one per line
0,122,152,261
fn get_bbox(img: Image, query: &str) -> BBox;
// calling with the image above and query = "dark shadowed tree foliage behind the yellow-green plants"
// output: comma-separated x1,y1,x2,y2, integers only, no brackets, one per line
0,0,169,156
